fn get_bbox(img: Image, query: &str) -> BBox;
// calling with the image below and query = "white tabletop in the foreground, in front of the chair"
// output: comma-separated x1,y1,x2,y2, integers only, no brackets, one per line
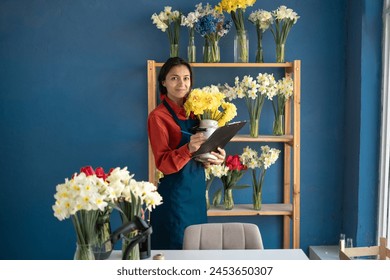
109,249,309,260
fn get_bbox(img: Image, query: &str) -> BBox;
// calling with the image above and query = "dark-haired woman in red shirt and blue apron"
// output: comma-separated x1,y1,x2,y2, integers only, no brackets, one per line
148,57,226,249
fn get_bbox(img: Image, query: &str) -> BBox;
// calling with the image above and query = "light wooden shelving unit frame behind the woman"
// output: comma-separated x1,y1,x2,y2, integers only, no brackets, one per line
147,60,301,249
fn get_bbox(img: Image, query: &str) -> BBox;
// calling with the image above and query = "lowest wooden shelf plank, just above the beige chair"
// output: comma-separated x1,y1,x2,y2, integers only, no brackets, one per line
207,203,292,217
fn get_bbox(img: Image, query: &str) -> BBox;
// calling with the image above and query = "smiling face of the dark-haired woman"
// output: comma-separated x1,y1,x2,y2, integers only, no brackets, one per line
162,65,191,105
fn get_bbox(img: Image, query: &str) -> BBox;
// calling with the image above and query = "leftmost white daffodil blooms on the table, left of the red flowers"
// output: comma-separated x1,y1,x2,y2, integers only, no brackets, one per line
52,173,110,221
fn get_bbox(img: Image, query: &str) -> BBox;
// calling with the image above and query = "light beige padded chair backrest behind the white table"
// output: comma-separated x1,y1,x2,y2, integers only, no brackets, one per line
183,223,264,250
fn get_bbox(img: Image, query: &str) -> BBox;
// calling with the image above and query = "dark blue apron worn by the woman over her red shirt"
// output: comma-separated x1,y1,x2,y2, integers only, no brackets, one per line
150,100,207,250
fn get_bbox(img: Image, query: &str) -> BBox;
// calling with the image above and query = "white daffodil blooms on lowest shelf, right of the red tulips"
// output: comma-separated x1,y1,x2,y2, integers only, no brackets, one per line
240,145,280,170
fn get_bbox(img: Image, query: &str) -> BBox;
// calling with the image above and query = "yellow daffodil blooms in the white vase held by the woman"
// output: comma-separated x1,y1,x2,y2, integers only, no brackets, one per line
184,85,237,126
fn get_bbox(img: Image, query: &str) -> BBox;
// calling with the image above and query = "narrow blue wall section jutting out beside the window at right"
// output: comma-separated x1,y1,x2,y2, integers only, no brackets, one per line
343,0,383,244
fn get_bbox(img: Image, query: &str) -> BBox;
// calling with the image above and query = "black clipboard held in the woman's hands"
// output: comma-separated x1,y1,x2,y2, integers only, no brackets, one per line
192,121,246,158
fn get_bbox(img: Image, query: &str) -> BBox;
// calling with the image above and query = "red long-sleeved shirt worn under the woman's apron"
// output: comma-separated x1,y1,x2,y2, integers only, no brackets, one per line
148,95,191,175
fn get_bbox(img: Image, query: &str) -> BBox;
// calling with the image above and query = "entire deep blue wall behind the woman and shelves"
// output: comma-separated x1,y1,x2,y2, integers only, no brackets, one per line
0,0,382,259
